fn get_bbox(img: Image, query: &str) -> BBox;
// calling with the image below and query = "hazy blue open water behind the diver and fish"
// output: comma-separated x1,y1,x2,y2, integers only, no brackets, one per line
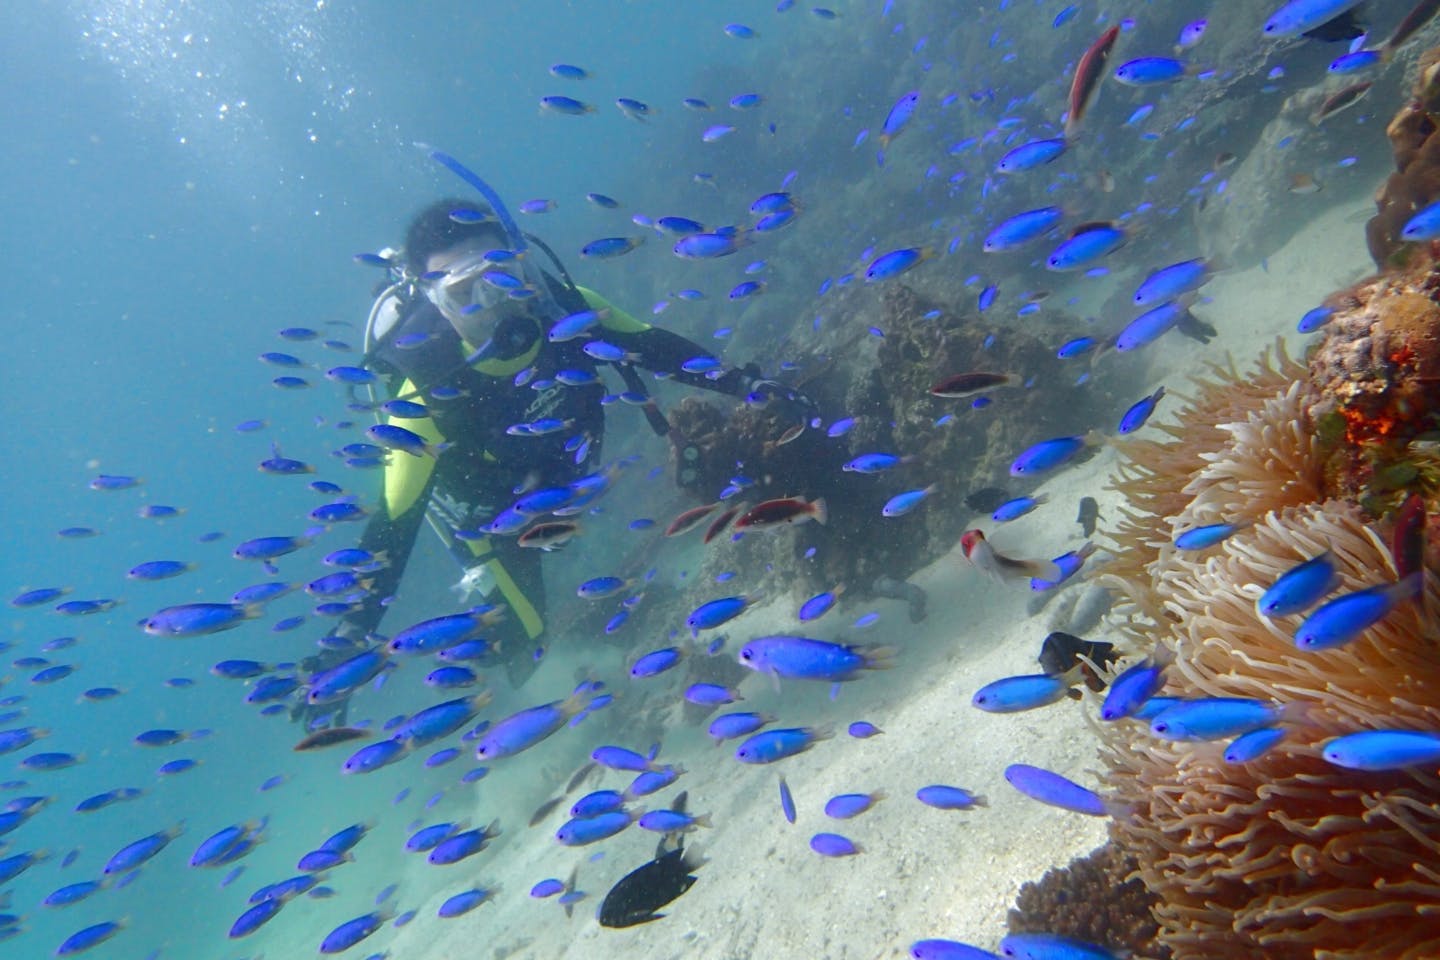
0,0,1416,959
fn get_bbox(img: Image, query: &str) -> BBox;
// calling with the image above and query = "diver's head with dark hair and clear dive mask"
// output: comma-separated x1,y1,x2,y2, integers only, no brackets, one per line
405,199,539,345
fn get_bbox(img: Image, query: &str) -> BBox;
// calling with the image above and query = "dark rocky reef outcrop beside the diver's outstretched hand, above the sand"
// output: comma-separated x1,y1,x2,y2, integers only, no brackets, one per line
671,277,1100,590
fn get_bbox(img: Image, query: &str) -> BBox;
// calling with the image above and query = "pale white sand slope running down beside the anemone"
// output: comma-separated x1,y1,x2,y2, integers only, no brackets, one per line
357,198,1368,960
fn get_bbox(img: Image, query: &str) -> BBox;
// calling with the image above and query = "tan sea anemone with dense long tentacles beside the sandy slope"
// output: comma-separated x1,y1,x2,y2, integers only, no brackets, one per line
1102,346,1440,960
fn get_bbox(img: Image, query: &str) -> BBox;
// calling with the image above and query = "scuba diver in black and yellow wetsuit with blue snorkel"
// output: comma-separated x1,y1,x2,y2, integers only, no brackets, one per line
295,178,814,724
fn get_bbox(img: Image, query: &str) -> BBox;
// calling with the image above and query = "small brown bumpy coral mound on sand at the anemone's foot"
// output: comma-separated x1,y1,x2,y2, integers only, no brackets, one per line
1007,843,1171,960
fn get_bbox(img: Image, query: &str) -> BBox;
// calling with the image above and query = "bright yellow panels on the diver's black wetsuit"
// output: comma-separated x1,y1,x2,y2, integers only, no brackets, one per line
384,286,649,639
